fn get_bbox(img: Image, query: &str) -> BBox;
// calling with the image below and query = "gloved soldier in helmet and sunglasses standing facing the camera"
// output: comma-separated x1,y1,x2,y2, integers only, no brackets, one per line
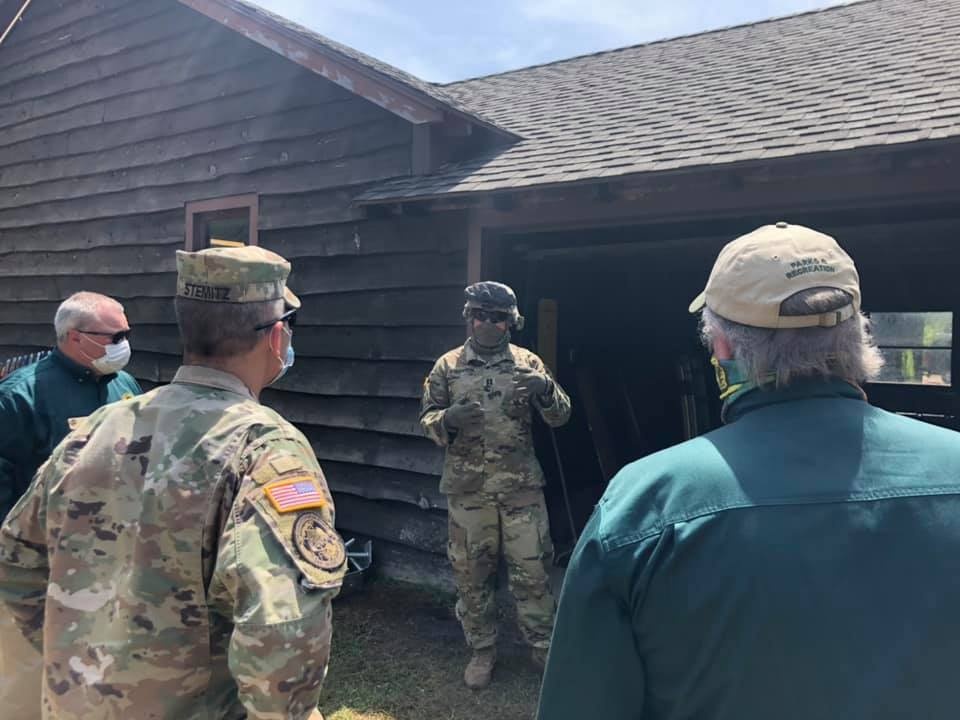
420,282,570,689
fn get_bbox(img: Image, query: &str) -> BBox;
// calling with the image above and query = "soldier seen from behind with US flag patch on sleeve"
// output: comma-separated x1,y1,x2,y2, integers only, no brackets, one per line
0,247,346,720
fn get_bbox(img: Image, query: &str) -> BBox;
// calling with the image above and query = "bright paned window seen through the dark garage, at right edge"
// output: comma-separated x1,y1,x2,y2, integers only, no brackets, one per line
870,312,953,387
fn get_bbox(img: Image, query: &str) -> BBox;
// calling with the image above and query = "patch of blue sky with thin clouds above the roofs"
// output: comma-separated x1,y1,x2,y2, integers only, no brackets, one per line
255,0,841,82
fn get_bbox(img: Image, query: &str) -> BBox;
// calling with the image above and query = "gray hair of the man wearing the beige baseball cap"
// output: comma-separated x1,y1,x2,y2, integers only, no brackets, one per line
701,288,883,387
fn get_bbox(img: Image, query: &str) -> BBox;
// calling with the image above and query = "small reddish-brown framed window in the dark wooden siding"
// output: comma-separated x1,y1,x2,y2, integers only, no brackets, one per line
186,195,259,250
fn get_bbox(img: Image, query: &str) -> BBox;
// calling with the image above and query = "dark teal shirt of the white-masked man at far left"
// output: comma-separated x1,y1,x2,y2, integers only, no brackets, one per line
0,350,142,521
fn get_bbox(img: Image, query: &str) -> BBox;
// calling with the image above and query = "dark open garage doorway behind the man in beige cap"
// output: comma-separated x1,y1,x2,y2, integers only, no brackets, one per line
496,208,960,556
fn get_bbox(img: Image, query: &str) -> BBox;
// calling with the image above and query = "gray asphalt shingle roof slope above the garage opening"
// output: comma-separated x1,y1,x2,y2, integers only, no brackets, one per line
360,0,960,201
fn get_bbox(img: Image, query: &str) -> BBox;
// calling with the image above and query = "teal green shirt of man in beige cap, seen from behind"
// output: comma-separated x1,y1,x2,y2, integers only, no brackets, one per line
538,382,960,720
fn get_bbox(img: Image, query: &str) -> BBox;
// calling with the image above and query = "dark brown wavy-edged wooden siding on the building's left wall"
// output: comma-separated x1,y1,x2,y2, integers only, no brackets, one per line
0,0,466,584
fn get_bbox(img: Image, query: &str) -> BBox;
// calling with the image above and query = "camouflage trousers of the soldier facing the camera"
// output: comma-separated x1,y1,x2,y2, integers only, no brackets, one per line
447,488,556,649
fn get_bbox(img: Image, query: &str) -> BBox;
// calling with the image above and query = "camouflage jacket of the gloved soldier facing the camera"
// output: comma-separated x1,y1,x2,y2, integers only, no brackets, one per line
420,340,570,494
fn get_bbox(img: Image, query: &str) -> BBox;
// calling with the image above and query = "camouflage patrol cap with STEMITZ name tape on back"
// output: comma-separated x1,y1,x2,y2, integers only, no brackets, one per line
177,245,300,309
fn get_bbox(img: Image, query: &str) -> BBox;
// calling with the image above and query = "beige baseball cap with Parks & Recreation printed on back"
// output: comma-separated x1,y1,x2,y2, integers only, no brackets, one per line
690,222,860,329
